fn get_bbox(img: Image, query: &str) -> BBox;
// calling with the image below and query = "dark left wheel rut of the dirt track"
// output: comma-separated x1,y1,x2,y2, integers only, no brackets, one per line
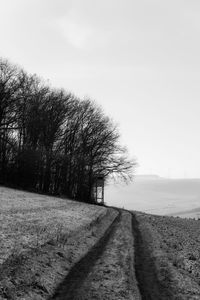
49,210,121,300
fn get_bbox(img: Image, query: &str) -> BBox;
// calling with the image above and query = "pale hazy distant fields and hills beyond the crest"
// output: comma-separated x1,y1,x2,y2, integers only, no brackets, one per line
105,177,200,218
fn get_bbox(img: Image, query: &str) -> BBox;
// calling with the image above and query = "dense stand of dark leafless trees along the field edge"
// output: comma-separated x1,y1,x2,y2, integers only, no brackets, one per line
0,59,134,202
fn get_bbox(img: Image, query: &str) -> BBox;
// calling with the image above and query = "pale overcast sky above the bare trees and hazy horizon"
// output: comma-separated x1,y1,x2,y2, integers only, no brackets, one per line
0,0,200,178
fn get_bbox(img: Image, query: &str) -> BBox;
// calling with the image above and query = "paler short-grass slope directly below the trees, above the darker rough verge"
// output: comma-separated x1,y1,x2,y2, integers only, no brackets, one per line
0,187,105,264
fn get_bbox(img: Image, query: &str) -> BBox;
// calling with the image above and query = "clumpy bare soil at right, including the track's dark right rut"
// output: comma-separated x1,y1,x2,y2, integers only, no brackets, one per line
134,213,200,300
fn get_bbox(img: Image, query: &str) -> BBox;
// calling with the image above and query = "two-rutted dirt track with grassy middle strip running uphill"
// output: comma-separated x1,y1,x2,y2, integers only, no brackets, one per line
51,211,173,300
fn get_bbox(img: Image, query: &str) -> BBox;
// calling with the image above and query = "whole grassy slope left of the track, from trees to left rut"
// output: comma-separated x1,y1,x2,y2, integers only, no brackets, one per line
0,187,116,300
